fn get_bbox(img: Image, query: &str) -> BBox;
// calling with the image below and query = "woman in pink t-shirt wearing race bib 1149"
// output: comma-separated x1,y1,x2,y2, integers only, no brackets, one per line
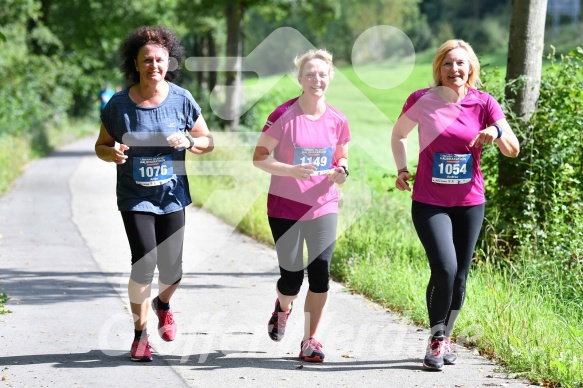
253,50,350,362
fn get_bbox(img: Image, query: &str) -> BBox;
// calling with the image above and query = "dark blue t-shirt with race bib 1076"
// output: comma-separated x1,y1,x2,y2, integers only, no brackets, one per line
101,82,200,214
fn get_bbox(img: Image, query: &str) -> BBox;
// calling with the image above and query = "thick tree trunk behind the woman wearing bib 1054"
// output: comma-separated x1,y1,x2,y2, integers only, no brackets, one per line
498,0,547,187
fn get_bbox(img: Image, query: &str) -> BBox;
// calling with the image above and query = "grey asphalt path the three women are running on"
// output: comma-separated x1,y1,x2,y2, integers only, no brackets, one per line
0,138,540,388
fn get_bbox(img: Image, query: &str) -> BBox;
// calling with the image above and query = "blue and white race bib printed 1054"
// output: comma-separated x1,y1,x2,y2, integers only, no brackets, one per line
431,152,472,185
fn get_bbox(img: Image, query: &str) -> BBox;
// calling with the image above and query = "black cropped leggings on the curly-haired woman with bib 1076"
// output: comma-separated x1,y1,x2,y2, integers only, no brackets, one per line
121,209,185,285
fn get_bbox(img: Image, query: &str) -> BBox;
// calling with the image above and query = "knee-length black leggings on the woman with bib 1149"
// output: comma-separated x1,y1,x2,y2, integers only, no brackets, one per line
268,213,338,296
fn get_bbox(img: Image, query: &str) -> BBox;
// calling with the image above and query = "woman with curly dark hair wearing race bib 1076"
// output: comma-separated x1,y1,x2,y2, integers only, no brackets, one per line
95,26,214,361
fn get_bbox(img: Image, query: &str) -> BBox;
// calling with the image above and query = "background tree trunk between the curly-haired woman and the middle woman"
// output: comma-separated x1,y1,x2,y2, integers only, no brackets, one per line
223,0,244,129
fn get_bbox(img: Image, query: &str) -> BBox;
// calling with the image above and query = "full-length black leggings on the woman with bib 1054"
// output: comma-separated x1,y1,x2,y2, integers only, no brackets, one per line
411,201,484,336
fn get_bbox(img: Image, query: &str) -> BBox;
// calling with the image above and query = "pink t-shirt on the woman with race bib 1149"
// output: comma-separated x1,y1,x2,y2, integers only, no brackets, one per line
263,98,350,220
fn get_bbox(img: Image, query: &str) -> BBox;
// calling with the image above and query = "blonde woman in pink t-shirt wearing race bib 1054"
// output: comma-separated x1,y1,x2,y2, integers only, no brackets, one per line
391,40,520,370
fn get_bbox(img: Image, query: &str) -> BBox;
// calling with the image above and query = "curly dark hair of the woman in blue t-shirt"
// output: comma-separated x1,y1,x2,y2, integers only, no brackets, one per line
119,26,184,85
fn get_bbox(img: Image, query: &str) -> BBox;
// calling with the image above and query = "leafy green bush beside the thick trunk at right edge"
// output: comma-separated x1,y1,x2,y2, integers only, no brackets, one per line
480,48,583,310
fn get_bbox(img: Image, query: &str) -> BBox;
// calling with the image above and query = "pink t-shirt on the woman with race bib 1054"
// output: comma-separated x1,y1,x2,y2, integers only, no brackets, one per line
403,88,505,207
